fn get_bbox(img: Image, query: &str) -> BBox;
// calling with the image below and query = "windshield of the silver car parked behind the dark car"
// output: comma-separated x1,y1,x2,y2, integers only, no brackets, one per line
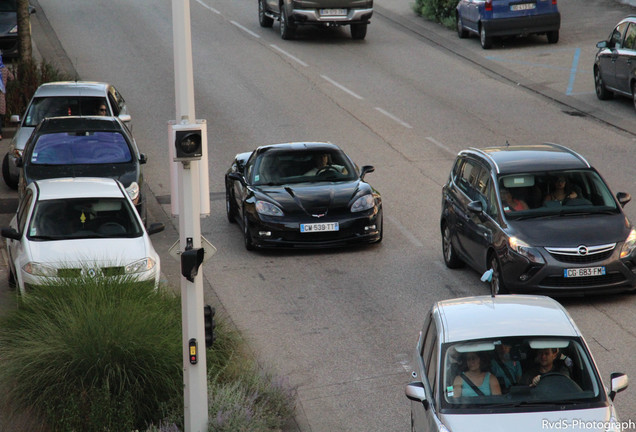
24,96,110,127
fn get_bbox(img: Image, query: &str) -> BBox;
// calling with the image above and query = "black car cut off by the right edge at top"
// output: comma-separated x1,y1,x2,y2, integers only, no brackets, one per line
594,16,636,108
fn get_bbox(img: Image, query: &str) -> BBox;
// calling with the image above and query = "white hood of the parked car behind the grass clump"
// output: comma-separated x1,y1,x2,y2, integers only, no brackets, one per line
28,237,156,266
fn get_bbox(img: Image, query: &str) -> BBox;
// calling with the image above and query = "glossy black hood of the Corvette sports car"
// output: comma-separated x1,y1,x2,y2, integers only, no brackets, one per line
257,181,370,215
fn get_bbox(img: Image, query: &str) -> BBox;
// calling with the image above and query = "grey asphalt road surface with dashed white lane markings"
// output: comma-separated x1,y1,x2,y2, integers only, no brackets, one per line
0,0,636,431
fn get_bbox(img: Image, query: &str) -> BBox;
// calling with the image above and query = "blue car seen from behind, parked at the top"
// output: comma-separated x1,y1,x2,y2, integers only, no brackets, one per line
456,0,561,49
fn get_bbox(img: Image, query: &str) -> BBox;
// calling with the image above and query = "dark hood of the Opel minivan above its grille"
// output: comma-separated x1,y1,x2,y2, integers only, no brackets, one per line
508,213,630,247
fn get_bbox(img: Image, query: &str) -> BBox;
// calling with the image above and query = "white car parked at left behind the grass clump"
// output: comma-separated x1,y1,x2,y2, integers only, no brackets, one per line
2,177,165,294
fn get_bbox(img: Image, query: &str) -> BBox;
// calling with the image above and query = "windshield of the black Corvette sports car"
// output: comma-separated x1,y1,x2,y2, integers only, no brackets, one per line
248,149,358,185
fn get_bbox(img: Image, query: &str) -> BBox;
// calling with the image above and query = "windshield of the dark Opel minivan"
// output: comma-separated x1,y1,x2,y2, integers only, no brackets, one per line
498,169,620,219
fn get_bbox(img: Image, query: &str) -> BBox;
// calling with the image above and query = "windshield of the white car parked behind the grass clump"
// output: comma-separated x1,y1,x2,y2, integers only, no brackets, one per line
27,198,143,241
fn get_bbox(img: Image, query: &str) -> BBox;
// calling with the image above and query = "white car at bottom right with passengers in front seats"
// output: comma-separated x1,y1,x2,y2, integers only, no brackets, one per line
406,295,628,432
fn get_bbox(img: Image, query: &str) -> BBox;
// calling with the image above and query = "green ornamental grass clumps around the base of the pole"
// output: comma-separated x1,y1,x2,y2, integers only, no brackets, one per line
0,277,295,432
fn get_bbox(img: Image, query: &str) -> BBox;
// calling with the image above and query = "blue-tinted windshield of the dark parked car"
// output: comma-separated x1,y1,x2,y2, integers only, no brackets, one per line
31,132,132,165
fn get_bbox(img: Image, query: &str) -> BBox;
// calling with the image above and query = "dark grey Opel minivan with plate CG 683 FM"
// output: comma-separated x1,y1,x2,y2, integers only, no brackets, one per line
440,144,636,295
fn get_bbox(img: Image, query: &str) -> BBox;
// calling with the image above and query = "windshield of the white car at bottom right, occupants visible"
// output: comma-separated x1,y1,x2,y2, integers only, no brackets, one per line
440,336,604,409
